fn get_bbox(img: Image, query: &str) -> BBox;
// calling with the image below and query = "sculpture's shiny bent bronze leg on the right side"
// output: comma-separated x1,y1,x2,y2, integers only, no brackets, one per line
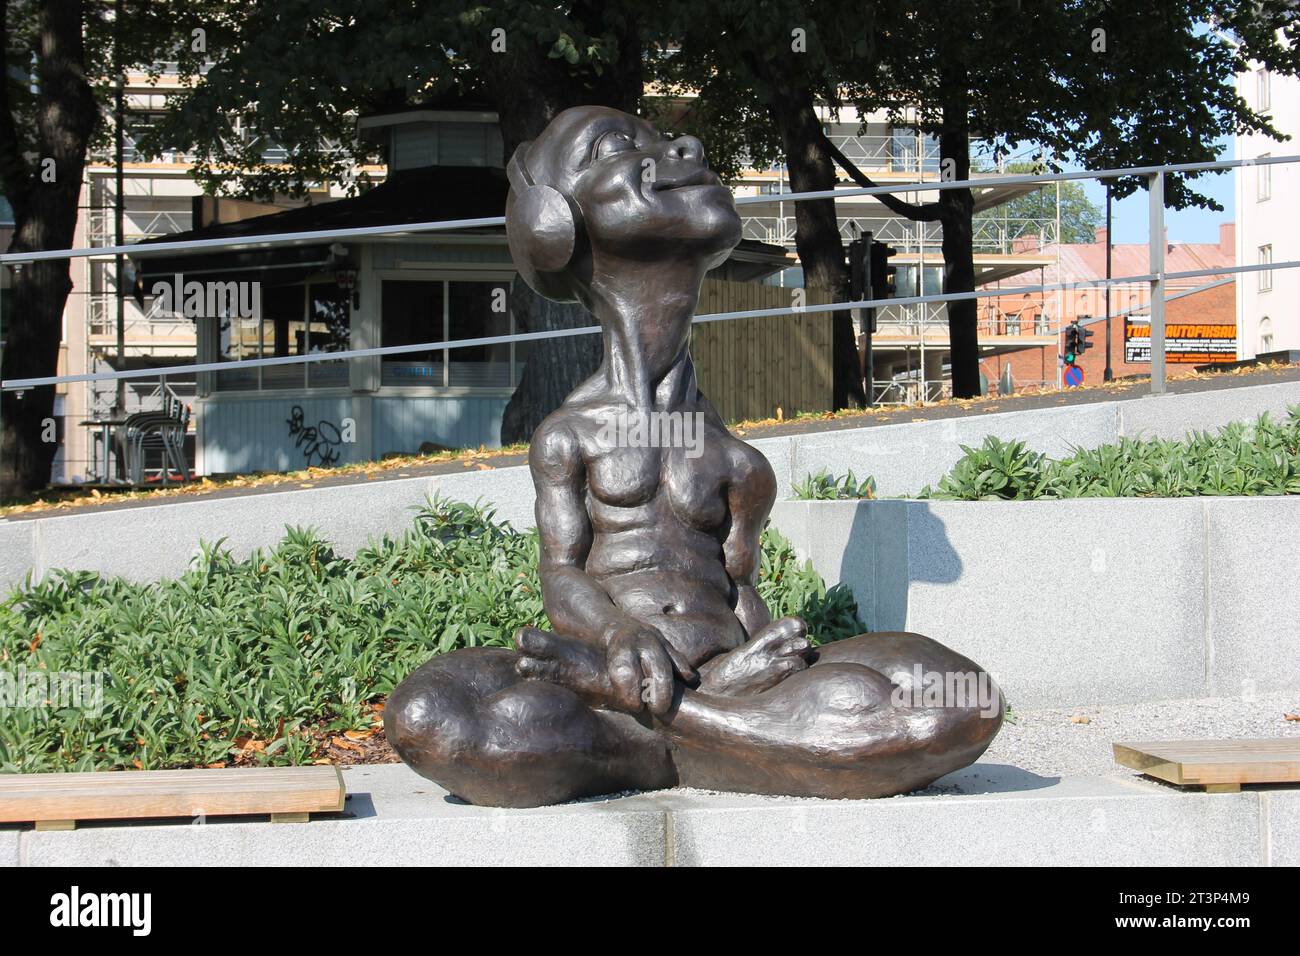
670,633,1005,799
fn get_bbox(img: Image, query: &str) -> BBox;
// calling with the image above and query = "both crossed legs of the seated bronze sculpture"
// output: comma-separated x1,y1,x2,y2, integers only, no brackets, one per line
385,630,1002,806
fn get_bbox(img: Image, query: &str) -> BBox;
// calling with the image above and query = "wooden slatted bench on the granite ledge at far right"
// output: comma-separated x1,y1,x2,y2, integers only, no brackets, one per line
1113,737,1300,793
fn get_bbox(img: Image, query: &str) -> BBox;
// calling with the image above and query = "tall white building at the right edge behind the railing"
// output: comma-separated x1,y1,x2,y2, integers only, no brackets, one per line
1236,64,1300,359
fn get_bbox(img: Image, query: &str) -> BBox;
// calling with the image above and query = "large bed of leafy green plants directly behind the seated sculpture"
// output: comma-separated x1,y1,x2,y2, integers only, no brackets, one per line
0,502,865,773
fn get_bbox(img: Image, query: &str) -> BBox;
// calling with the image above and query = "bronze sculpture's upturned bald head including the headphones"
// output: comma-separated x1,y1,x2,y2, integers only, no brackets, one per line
506,107,740,302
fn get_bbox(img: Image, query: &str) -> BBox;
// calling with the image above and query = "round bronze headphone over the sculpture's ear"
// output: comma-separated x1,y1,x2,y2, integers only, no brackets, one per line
506,140,582,302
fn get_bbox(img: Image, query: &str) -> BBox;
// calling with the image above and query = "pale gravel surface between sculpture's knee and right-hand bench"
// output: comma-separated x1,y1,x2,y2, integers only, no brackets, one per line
980,692,1300,777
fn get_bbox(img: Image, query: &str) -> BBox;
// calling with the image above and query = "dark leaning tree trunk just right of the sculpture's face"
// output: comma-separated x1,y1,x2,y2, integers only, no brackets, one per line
768,82,867,408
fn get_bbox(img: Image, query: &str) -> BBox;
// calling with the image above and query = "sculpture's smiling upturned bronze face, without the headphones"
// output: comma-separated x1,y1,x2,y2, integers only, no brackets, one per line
529,107,741,269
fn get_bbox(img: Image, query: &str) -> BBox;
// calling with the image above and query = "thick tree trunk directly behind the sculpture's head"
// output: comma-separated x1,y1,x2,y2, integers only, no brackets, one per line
481,4,642,445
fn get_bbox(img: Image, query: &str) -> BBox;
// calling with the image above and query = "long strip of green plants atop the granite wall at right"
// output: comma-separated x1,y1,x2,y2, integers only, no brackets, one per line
919,406,1300,501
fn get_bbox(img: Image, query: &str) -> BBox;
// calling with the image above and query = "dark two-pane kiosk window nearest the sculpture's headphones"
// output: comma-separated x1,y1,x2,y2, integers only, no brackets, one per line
380,280,528,389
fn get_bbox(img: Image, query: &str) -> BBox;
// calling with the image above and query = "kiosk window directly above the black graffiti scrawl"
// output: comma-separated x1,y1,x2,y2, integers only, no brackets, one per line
216,282,352,392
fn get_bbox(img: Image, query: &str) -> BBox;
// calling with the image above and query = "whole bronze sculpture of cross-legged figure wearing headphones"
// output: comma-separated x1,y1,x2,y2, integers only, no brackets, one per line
385,107,1002,806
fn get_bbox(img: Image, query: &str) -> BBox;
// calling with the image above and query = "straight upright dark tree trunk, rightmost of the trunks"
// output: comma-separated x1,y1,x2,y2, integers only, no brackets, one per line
939,81,979,398
